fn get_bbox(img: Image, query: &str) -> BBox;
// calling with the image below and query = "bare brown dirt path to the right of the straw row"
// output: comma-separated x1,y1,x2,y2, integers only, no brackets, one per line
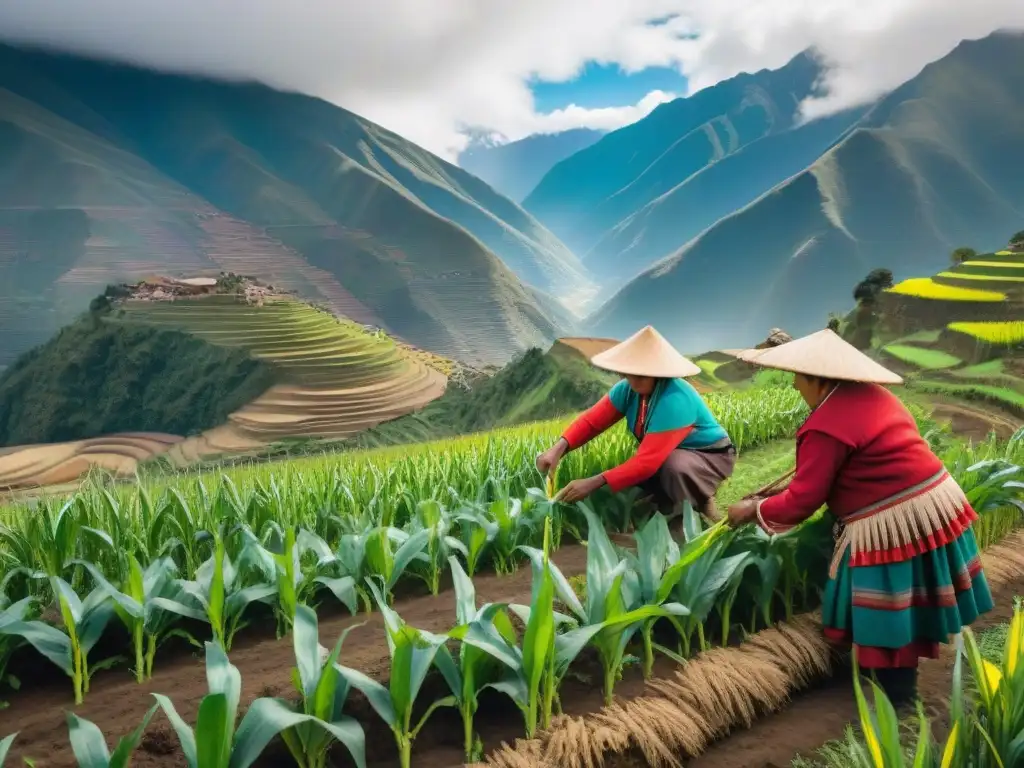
687,574,1024,768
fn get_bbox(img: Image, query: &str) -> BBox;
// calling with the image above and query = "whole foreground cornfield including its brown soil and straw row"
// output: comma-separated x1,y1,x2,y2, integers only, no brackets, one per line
0,376,1024,768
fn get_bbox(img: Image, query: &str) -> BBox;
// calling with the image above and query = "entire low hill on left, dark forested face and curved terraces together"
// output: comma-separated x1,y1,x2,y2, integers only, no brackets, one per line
0,281,455,488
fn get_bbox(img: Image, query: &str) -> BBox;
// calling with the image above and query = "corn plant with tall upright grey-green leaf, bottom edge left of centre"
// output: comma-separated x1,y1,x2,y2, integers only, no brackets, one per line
281,604,366,768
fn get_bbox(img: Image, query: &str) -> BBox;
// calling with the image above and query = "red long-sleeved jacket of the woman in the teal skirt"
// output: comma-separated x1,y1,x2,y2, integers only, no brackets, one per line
759,382,943,528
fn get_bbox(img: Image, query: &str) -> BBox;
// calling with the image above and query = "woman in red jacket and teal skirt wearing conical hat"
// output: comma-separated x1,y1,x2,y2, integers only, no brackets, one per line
729,331,992,709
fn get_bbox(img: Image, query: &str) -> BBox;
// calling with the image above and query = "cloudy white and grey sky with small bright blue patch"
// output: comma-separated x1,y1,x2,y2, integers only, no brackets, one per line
0,0,1024,159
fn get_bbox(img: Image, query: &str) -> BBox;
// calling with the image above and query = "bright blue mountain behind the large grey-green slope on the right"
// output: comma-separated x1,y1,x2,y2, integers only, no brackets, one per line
523,53,863,284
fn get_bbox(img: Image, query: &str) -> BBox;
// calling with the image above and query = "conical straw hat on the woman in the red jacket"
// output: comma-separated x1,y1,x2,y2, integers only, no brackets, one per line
733,329,903,384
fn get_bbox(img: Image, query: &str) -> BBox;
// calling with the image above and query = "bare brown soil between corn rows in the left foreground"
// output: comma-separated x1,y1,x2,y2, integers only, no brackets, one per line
0,545,587,768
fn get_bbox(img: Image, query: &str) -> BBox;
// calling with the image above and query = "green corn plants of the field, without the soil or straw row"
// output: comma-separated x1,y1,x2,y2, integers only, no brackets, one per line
0,389,1024,768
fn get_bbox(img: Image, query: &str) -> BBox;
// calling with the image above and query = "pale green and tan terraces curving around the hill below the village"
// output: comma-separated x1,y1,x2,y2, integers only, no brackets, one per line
0,295,449,487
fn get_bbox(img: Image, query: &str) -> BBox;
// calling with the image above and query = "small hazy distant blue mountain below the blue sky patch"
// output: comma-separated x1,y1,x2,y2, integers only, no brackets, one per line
459,128,605,202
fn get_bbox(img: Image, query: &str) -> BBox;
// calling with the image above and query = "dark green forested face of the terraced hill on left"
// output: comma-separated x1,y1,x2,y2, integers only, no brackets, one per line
0,315,280,448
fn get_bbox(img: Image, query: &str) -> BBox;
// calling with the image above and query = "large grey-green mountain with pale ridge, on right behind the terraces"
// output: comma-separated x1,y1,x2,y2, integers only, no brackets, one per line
587,33,1024,349
